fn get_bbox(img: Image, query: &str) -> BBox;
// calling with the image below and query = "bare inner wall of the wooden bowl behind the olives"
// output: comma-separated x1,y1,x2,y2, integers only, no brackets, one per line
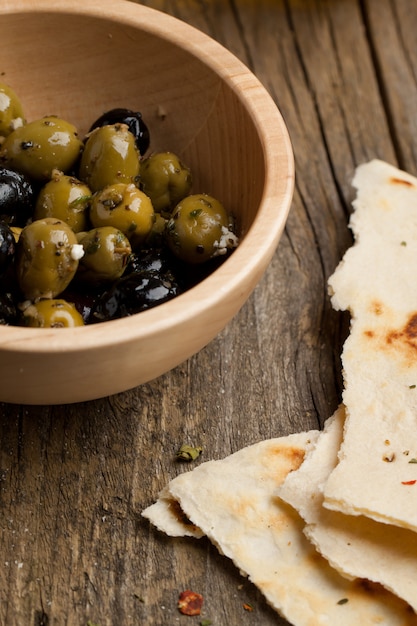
0,10,265,236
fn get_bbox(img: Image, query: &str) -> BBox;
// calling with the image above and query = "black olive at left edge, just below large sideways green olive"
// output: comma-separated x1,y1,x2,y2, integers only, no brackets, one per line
0,167,35,227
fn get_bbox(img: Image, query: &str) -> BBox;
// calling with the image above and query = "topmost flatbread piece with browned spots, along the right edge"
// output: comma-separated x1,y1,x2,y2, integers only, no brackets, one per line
324,160,417,531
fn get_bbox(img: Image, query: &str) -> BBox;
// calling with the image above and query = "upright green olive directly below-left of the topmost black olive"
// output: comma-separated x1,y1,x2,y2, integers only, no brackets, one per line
78,124,140,192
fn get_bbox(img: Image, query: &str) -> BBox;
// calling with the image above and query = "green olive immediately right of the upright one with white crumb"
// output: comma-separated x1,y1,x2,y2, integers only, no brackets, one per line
77,226,132,285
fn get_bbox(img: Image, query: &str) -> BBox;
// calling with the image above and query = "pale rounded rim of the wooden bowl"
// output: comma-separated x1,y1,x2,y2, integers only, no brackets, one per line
0,0,295,353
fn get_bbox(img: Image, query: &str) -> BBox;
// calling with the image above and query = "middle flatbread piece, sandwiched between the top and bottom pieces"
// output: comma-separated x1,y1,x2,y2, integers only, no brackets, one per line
277,406,417,611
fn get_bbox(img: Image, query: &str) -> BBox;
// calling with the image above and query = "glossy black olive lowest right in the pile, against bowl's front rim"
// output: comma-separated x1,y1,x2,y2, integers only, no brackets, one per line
90,271,180,322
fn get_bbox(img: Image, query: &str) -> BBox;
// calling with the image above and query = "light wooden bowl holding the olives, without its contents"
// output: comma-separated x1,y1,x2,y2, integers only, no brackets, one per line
0,0,294,404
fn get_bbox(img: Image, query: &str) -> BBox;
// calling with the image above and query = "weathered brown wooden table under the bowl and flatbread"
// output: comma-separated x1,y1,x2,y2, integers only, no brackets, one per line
0,0,417,626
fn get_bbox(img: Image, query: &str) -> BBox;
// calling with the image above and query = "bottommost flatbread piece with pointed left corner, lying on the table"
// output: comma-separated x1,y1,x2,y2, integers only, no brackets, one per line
142,431,417,626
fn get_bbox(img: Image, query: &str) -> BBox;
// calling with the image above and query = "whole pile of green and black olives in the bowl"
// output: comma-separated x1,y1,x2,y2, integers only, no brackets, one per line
0,83,238,328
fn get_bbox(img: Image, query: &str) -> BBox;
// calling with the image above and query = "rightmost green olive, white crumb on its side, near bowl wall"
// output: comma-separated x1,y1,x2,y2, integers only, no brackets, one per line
166,194,235,263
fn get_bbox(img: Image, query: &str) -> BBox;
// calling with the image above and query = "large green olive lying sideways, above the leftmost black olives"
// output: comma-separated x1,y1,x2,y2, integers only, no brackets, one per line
0,115,82,182
